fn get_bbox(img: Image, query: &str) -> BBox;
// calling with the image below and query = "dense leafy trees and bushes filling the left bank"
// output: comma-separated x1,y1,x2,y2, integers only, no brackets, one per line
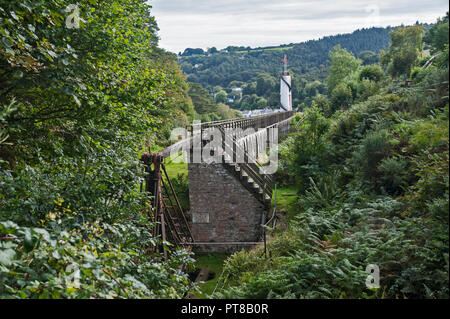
0,0,195,298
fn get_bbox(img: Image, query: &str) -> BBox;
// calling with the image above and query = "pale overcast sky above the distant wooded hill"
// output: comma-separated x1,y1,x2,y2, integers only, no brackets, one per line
149,0,449,53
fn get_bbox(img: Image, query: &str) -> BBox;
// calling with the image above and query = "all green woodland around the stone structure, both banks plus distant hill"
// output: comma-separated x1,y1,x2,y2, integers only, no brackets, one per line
0,0,449,299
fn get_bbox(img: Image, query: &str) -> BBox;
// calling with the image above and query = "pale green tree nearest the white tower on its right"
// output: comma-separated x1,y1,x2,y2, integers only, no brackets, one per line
326,45,361,95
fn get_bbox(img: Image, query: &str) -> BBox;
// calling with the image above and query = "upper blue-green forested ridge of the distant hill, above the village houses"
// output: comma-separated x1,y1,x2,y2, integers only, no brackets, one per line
180,28,391,87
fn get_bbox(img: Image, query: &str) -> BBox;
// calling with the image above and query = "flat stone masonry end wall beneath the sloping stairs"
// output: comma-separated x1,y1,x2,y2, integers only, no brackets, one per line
189,163,266,252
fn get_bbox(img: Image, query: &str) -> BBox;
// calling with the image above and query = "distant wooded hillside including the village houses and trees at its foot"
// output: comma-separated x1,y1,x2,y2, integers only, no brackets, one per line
179,28,402,110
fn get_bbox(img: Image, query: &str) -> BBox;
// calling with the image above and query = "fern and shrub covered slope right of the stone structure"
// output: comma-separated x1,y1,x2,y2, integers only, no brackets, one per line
215,18,449,298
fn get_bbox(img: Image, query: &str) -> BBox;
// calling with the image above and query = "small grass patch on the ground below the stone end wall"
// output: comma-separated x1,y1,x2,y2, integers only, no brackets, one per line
194,253,230,299
